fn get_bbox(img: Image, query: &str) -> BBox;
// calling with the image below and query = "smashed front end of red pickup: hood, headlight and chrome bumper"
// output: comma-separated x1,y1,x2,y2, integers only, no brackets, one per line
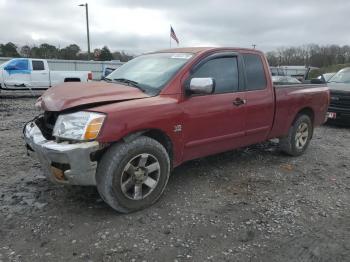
23,82,150,185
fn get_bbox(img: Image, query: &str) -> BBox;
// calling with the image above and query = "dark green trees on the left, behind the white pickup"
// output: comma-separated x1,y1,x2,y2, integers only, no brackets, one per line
0,42,133,62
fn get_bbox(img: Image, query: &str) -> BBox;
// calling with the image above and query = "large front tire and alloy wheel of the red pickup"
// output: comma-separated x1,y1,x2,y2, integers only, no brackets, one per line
96,136,170,213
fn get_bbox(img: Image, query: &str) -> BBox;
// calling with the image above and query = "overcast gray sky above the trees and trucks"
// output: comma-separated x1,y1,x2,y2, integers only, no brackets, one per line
0,0,350,54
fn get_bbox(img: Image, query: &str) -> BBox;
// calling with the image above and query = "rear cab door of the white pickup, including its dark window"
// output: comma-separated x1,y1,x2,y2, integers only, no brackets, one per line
31,59,50,89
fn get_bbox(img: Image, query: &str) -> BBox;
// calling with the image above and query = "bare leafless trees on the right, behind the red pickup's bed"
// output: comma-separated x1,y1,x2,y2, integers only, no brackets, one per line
266,44,350,67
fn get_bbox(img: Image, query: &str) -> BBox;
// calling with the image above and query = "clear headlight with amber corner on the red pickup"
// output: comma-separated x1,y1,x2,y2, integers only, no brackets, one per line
53,111,106,141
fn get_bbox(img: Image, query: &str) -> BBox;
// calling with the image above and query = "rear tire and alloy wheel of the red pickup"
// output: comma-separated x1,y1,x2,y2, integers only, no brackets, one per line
279,115,313,156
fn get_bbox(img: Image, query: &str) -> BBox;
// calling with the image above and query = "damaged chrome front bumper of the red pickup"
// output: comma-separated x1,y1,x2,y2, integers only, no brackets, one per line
23,122,100,185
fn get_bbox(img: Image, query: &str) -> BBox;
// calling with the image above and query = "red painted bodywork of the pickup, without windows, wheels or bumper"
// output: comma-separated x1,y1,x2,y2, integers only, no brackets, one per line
42,48,329,166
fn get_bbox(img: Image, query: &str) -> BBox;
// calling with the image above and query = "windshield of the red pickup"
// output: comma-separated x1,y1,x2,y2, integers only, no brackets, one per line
106,53,193,93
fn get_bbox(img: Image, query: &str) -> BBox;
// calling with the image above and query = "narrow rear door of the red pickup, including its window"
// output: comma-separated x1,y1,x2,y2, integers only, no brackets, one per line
242,53,275,144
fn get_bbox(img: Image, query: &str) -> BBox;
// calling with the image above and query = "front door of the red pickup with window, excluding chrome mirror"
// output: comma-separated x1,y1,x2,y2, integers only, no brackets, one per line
182,53,245,160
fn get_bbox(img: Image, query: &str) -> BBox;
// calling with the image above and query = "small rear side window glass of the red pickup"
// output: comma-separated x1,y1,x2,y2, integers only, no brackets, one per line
243,54,266,90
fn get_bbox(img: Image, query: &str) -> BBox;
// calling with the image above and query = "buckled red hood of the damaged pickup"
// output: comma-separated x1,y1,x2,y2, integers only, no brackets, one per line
36,82,150,111
